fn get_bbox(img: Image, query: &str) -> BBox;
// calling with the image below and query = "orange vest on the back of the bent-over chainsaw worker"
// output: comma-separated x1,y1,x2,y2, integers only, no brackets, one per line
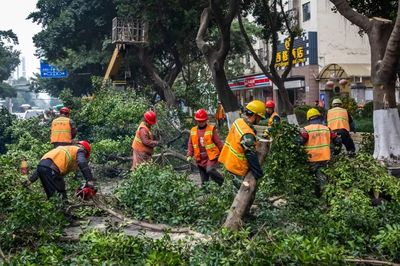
42,145,79,175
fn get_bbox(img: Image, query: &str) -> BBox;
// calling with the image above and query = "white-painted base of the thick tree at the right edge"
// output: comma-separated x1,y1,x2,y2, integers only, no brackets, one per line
374,108,400,163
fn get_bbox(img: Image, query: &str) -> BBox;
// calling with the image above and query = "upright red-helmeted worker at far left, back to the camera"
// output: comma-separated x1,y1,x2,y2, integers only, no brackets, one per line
50,107,77,147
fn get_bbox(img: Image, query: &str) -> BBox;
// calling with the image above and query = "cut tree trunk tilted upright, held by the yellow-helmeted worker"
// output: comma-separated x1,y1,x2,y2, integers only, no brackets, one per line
224,140,270,230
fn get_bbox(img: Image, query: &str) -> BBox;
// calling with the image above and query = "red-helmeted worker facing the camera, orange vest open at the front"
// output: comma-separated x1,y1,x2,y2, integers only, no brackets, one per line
187,109,224,186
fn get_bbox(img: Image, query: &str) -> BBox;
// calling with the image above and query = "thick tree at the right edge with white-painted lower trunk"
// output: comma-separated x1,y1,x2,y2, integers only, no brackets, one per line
330,0,400,161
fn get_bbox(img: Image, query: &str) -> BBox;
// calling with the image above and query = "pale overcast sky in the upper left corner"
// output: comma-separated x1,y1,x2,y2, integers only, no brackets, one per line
0,0,41,78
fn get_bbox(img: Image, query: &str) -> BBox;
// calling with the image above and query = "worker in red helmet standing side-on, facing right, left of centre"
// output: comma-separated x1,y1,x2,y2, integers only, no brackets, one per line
131,111,159,170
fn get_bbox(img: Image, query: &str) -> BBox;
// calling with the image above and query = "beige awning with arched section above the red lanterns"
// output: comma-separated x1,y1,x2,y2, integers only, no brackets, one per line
317,64,371,80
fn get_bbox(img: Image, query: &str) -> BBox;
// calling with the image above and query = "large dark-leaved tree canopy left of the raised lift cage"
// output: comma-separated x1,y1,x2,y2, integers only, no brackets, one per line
28,0,116,96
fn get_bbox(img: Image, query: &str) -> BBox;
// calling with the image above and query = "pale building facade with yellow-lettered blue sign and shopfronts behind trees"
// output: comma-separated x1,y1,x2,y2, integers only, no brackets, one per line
230,0,372,108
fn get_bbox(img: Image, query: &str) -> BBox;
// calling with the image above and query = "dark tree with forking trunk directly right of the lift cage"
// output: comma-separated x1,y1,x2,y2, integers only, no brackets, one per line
116,0,204,106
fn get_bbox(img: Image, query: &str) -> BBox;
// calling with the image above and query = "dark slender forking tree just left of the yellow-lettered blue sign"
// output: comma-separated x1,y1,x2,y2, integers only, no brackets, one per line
238,0,301,117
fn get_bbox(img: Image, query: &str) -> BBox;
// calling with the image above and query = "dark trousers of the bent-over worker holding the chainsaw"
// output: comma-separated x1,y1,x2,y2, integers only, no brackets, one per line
36,165,67,200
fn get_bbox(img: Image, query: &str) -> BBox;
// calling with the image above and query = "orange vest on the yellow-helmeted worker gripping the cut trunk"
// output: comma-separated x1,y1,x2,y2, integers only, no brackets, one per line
218,118,255,176
